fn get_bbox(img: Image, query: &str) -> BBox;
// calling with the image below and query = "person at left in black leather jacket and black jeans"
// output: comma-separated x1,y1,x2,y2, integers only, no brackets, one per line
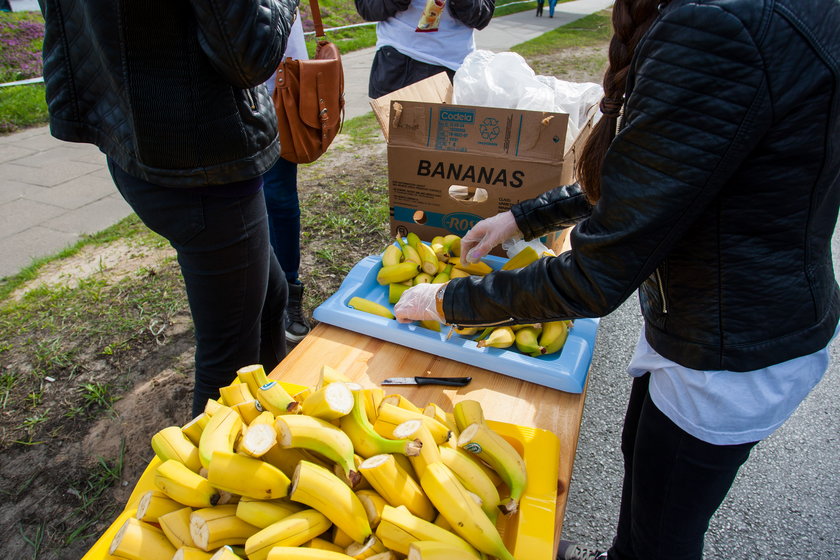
40,0,298,416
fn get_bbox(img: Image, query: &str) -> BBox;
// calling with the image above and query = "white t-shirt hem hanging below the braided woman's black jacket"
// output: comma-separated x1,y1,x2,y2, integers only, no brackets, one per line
627,328,837,445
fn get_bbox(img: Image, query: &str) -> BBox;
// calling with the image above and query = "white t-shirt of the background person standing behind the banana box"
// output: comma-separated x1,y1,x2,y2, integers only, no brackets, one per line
376,0,475,70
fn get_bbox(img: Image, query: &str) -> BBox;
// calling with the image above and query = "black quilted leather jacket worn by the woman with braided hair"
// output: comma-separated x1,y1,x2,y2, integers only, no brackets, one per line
443,0,840,371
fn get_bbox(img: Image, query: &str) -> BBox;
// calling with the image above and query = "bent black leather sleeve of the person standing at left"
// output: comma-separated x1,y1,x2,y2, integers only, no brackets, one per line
191,0,298,89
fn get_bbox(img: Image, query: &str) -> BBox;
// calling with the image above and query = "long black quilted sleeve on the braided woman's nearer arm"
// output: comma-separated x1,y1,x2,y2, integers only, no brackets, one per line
444,3,771,325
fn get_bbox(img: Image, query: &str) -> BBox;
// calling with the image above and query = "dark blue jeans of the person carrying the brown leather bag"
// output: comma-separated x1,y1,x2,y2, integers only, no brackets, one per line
263,158,300,284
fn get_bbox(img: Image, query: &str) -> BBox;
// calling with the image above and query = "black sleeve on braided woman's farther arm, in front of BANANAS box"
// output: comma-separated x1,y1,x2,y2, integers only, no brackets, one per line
511,183,592,240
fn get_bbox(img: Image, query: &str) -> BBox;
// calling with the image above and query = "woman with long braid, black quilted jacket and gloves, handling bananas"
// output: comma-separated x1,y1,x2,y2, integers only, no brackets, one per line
394,0,840,560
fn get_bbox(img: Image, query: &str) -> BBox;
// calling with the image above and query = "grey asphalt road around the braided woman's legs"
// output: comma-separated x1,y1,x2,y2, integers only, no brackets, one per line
563,228,840,560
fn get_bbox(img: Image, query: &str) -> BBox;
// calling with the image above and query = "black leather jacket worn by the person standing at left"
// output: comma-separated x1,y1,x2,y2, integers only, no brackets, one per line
40,0,298,187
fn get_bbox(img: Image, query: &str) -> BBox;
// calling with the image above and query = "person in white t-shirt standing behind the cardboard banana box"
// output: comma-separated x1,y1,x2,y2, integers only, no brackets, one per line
355,0,496,99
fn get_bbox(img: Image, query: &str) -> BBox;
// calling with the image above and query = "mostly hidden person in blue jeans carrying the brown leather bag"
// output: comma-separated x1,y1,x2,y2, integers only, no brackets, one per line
263,13,309,344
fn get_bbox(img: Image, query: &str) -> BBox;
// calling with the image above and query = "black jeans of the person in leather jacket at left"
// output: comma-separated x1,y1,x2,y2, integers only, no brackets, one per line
108,160,287,416
